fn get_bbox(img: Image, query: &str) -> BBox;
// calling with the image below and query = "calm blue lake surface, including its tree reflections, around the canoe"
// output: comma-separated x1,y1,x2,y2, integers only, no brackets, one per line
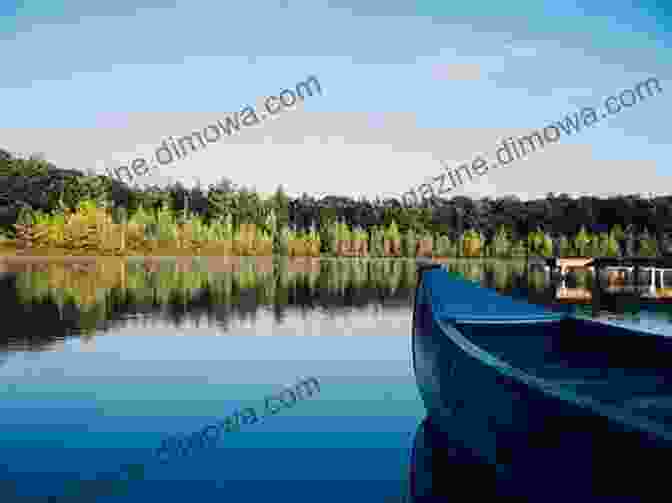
0,259,672,503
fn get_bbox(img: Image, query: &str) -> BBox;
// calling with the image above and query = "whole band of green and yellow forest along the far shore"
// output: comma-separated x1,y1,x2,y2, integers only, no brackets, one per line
0,149,672,257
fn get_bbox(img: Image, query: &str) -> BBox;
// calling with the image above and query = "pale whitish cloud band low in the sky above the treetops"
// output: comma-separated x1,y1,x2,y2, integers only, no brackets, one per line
5,97,672,203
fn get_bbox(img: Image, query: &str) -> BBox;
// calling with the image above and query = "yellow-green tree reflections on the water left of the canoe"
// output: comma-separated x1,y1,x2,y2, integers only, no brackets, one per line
0,257,416,351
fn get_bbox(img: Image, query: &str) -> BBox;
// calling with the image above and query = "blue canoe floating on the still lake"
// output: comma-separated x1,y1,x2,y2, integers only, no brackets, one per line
412,262,672,501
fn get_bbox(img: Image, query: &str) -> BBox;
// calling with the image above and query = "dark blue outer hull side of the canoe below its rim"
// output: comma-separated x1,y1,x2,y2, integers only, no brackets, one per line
412,264,672,501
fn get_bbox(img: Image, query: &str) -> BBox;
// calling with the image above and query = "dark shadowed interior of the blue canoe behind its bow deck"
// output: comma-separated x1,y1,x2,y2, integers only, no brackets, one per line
454,318,672,423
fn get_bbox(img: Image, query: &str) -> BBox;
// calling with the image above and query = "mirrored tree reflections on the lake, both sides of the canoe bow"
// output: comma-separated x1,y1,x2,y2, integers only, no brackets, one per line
0,257,672,356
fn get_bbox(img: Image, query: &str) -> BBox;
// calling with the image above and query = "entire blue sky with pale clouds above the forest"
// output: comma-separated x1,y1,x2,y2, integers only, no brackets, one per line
0,0,672,200
